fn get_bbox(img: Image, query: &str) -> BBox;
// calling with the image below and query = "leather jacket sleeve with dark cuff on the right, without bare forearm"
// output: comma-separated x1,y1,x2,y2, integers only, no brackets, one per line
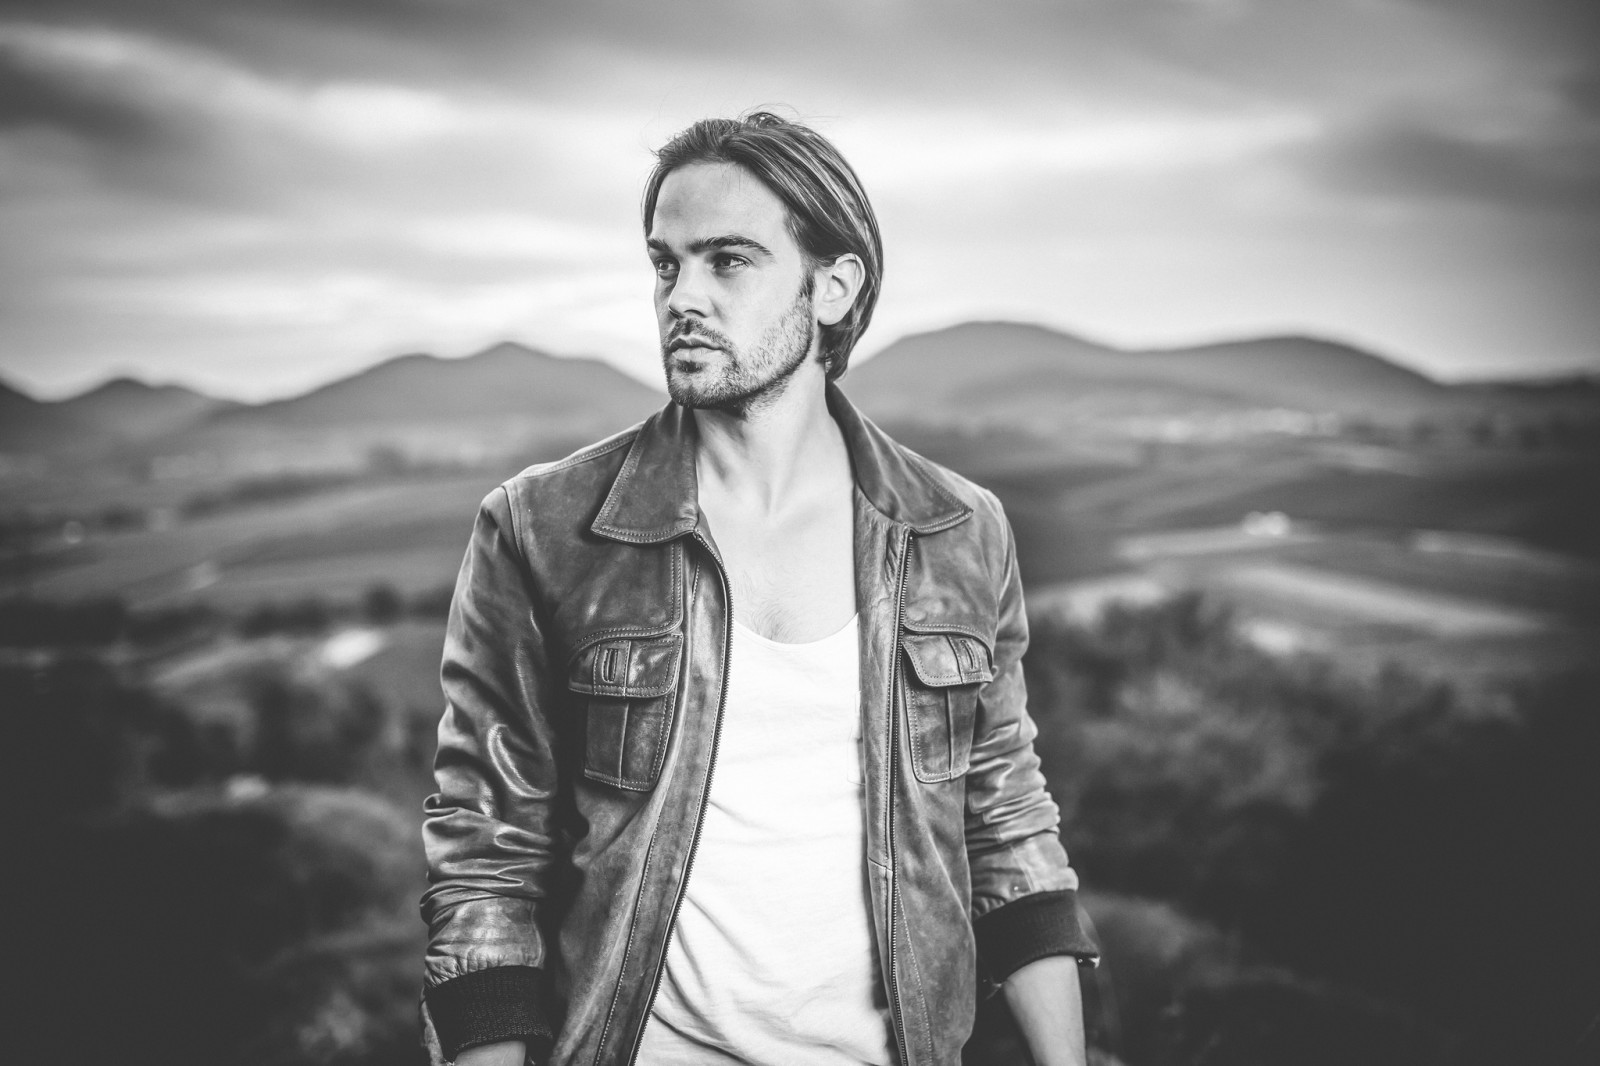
966,495,1099,988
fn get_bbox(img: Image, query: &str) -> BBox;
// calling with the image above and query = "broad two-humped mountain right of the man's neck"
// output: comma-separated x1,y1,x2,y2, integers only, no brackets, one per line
845,322,1459,418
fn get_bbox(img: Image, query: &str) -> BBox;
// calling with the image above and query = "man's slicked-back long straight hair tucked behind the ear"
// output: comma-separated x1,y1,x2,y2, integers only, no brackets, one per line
643,110,883,381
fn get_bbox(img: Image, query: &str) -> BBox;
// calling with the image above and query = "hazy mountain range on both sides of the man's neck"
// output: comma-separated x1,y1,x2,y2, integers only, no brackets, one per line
9,322,1600,475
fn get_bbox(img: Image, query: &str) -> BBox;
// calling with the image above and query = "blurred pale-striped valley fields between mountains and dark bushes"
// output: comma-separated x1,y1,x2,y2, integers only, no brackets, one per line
0,426,1600,704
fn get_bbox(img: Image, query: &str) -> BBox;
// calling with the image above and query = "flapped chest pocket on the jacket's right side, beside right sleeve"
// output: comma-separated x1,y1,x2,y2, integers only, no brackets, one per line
901,632,994,784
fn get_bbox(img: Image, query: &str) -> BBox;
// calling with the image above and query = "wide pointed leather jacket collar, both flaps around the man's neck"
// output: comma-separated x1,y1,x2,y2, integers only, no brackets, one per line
589,384,973,544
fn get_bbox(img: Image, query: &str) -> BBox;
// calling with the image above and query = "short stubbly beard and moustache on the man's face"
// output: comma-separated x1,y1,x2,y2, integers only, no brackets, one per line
661,277,816,418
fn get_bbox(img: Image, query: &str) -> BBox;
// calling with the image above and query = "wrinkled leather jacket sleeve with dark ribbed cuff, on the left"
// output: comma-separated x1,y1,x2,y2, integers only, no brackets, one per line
422,487,560,1060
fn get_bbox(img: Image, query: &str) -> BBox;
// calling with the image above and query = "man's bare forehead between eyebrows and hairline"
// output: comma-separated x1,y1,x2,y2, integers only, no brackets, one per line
650,163,798,251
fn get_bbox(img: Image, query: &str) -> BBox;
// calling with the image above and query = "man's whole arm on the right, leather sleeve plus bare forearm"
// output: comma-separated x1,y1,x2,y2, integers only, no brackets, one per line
966,496,1099,1066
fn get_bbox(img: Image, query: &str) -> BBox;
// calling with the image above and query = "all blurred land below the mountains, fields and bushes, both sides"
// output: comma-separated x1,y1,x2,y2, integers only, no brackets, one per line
0,392,1600,1066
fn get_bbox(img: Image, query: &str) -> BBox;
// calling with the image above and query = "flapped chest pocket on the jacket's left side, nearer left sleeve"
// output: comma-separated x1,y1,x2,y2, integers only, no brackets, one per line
566,634,683,792
